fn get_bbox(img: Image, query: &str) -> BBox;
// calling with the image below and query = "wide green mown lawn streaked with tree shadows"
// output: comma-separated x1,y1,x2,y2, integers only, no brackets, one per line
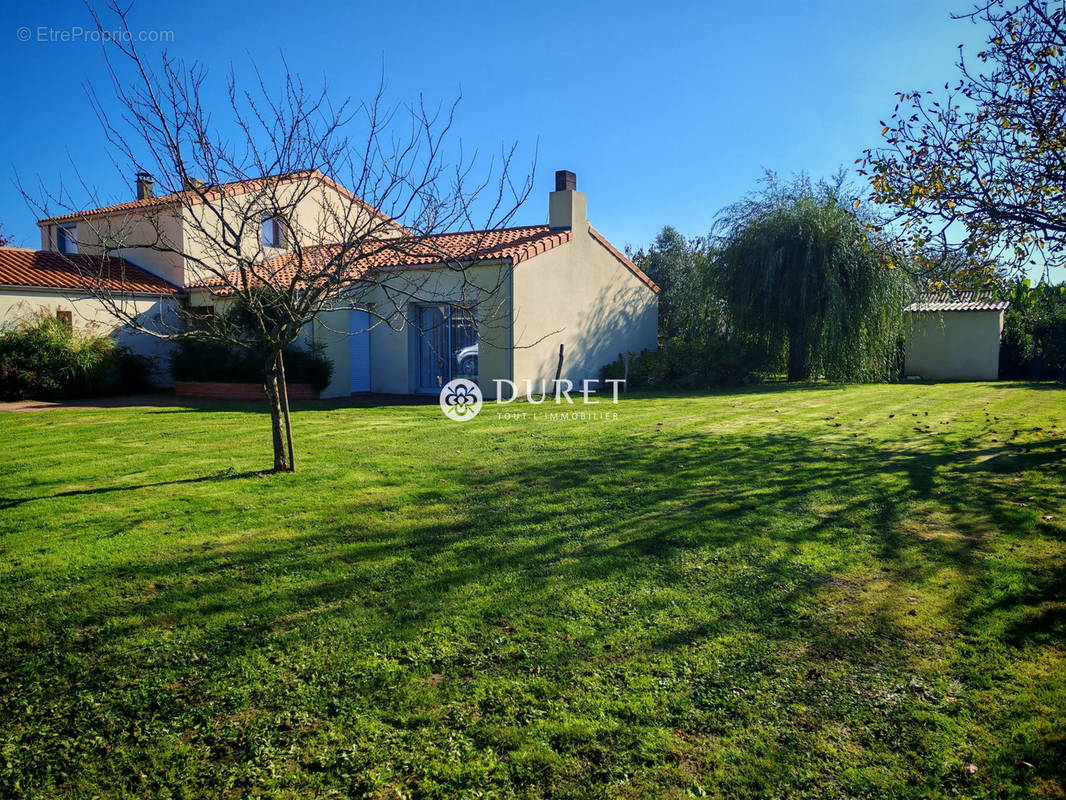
0,384,1066,798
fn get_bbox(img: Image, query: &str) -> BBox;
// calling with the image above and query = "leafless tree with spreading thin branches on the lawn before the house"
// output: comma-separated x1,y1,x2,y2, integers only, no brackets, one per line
23,5,532,471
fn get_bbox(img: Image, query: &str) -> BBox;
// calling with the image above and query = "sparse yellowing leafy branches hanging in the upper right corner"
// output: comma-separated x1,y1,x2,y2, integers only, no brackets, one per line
859,0,1066,273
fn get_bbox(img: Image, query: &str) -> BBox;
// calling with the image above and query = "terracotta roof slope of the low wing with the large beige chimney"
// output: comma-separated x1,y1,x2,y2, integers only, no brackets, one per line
188,225,571,294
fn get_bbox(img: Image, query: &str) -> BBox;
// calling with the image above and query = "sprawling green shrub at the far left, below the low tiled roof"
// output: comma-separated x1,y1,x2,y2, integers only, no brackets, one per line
0,315,151,400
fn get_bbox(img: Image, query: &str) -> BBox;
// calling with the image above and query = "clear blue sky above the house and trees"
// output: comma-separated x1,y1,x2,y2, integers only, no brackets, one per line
0,0,1006,266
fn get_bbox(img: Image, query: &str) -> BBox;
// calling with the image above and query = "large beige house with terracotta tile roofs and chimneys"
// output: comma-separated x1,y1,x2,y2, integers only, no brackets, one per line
0,171,659,398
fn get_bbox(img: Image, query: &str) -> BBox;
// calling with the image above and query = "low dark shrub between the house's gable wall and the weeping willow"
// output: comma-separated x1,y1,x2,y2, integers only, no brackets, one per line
603,338,763,389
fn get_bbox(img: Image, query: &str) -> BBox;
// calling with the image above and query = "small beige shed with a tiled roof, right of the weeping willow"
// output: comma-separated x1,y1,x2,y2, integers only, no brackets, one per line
904,291,1010,381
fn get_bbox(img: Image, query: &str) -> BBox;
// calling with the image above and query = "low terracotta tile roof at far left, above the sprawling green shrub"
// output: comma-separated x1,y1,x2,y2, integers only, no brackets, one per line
0,247,178,294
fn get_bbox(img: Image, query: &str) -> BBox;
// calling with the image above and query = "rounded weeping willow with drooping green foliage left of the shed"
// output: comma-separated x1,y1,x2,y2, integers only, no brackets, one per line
714,175,911,381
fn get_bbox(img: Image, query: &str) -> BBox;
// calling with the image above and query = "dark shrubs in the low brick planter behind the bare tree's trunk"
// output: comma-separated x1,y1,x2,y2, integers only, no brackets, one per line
171,339,334,391
